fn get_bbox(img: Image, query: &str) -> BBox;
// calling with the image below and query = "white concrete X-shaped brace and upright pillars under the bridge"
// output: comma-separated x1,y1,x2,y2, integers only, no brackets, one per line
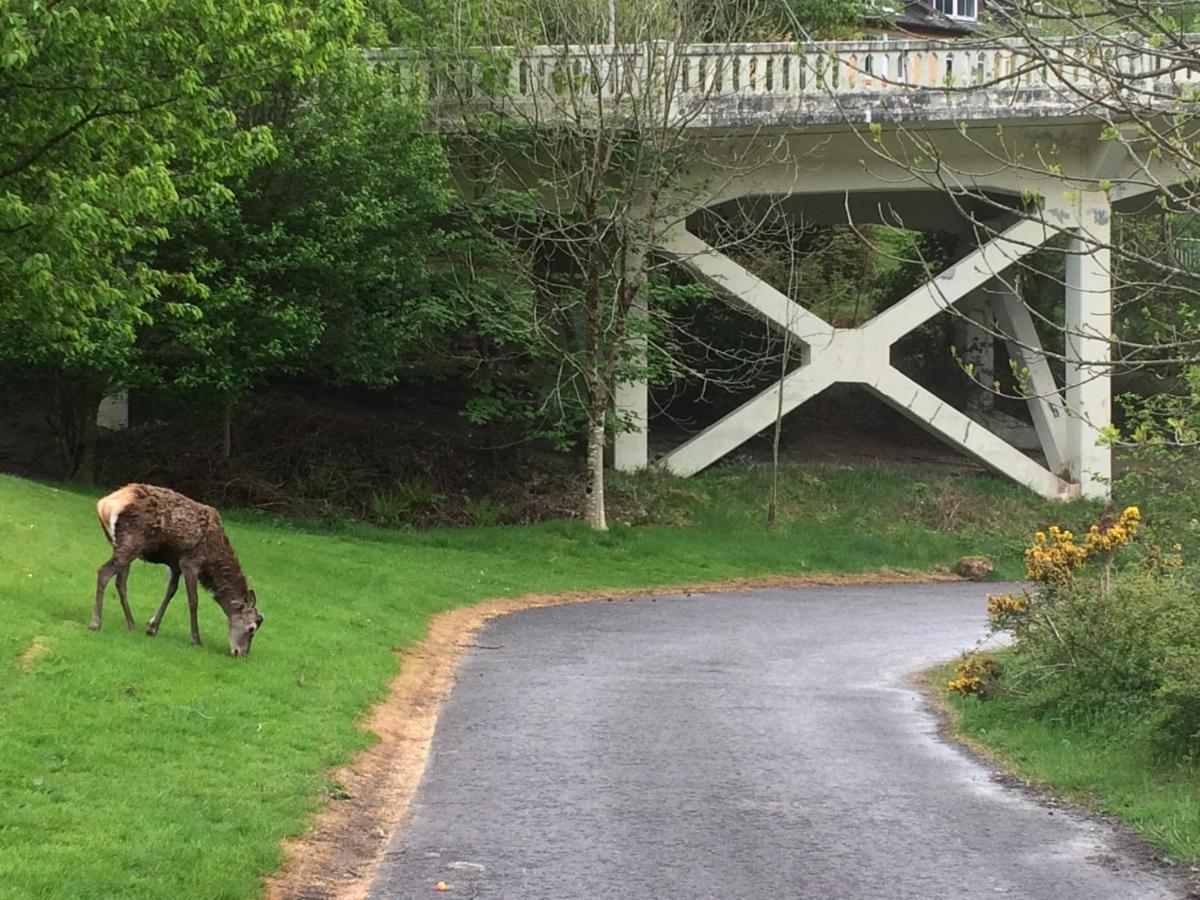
614,181,1111,499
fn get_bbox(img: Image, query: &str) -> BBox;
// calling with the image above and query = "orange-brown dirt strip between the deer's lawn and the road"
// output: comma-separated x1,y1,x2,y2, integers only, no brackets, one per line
263,569,959,900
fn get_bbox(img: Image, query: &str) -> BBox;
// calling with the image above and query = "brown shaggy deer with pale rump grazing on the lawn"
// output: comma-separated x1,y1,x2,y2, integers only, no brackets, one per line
91,484,263,656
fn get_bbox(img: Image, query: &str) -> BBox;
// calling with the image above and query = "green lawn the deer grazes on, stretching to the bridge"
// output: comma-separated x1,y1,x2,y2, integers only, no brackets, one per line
0,468,1091,900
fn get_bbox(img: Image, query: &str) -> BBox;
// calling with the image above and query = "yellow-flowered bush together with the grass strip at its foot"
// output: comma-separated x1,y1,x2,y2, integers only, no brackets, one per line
941,489,1200,860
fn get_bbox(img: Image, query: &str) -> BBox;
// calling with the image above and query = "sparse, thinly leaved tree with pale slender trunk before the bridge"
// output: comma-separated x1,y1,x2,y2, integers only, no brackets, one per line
427,0,864,529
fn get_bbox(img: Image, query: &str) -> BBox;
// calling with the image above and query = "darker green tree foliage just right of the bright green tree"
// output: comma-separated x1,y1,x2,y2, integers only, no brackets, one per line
146,49,453,412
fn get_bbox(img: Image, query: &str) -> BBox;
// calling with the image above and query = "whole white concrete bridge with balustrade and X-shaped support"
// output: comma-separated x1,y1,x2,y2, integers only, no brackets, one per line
405,42,1200,498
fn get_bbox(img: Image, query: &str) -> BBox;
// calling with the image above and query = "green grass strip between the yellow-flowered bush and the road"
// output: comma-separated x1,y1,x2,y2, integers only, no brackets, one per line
931,666,1200,862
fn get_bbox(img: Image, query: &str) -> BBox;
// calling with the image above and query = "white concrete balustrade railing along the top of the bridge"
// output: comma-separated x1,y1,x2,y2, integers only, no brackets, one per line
374,41,1200,112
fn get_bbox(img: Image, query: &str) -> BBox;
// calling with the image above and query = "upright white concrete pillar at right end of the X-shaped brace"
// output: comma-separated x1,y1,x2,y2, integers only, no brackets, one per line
1066,192,1112,499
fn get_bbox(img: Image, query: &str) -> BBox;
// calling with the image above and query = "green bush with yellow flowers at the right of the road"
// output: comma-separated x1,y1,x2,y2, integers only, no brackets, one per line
949,506,1200,761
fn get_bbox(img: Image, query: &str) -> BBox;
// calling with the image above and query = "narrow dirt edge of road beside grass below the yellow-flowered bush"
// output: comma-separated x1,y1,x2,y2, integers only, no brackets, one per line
910,666,1200,900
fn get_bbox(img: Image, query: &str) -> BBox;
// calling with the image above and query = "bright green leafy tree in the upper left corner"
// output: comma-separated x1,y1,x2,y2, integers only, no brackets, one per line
0,0,360,480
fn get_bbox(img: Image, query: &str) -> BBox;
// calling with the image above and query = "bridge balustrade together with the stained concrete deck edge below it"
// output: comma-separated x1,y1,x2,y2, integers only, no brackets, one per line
377,40,1200,128
